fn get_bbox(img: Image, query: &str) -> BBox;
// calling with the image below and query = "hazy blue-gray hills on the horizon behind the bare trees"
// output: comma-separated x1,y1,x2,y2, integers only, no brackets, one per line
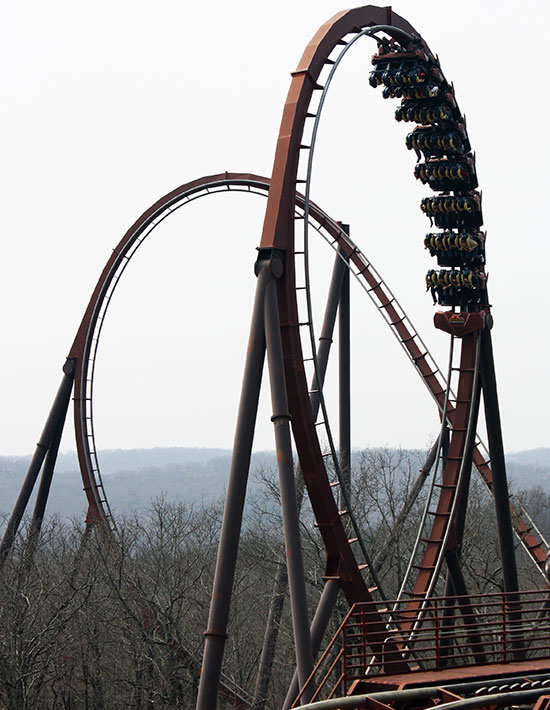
0,447,550,519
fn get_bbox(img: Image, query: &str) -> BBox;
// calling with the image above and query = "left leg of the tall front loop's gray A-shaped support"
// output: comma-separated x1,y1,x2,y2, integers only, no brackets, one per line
196,265,272,710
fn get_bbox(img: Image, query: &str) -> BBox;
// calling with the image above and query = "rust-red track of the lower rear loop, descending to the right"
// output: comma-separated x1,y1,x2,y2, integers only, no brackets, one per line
70,173,547,567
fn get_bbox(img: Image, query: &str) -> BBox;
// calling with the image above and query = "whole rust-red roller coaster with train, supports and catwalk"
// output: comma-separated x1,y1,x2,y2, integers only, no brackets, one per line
4,6,550,710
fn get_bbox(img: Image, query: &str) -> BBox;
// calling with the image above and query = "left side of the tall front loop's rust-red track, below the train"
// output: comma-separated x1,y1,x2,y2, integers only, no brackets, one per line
260,6,448,624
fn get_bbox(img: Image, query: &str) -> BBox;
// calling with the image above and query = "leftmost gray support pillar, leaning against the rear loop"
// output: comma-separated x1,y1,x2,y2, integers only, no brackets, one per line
0,360,74,567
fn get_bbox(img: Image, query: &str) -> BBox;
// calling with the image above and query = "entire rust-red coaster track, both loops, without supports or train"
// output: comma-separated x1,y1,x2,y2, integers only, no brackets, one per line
3,6,548,708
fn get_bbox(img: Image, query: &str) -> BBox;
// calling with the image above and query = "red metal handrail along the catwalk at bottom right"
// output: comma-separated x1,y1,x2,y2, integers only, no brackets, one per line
294,589,550,706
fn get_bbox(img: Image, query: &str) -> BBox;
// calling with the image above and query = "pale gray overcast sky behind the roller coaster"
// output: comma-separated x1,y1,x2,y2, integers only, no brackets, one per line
0,0,550,454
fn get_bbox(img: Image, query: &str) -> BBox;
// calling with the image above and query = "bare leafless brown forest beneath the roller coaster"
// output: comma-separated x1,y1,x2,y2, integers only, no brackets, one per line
0,449,550,710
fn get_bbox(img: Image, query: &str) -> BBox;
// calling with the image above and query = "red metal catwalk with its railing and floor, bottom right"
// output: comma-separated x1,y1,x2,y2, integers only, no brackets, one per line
300,589,550,707
